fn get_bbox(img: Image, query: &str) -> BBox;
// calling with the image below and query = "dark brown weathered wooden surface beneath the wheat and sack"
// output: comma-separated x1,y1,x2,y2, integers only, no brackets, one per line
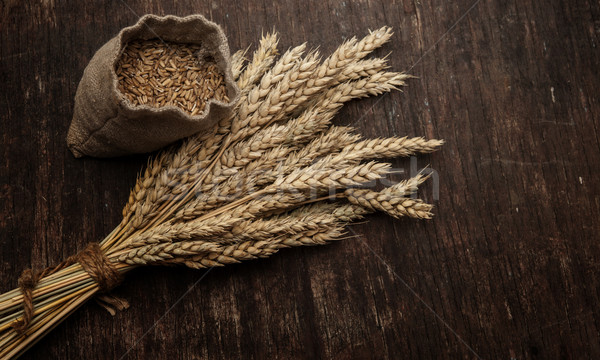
0,0,600,359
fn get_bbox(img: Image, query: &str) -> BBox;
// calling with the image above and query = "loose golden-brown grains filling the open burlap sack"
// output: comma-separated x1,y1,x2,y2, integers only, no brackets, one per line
116,39,229,116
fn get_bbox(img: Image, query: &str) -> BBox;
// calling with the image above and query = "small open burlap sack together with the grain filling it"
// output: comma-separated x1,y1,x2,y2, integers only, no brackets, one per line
67,15,239,157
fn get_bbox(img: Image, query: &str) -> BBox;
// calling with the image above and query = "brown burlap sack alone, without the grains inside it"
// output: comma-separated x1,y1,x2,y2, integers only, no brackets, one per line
67,15,239,157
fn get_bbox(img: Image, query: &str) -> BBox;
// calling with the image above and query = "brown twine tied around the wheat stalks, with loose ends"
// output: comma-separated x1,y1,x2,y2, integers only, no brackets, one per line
13,242,123,333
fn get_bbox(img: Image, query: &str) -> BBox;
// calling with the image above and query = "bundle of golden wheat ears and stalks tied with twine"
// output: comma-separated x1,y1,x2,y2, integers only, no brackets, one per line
0,27,443,358
